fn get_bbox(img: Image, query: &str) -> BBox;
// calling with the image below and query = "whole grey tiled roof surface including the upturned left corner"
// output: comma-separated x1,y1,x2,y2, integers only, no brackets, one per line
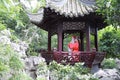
28,0,96,25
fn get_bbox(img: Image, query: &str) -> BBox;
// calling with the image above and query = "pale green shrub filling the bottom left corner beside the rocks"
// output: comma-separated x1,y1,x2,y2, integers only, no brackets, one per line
0,43,31,80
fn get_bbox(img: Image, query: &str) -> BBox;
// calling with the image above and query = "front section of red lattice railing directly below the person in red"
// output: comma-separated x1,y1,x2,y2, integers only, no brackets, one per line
53,52,95,67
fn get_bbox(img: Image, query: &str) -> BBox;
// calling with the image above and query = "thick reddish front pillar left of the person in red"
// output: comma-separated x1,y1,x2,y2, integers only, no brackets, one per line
58,24,63,52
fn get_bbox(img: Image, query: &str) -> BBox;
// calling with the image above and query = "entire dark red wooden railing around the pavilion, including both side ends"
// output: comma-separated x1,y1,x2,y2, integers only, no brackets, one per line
42,51,105,68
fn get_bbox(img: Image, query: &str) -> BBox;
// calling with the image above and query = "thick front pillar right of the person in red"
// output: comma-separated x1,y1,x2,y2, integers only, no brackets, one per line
86,24,90,51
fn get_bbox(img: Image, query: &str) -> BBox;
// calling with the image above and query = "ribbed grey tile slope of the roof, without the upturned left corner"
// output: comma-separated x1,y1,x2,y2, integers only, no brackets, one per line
47,0,96,17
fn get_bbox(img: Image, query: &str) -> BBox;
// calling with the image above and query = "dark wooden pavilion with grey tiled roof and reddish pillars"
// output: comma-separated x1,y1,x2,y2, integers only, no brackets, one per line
28,0,106,67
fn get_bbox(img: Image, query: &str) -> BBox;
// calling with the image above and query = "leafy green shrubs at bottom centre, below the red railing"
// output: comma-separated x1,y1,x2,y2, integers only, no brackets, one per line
46,61,97,80
